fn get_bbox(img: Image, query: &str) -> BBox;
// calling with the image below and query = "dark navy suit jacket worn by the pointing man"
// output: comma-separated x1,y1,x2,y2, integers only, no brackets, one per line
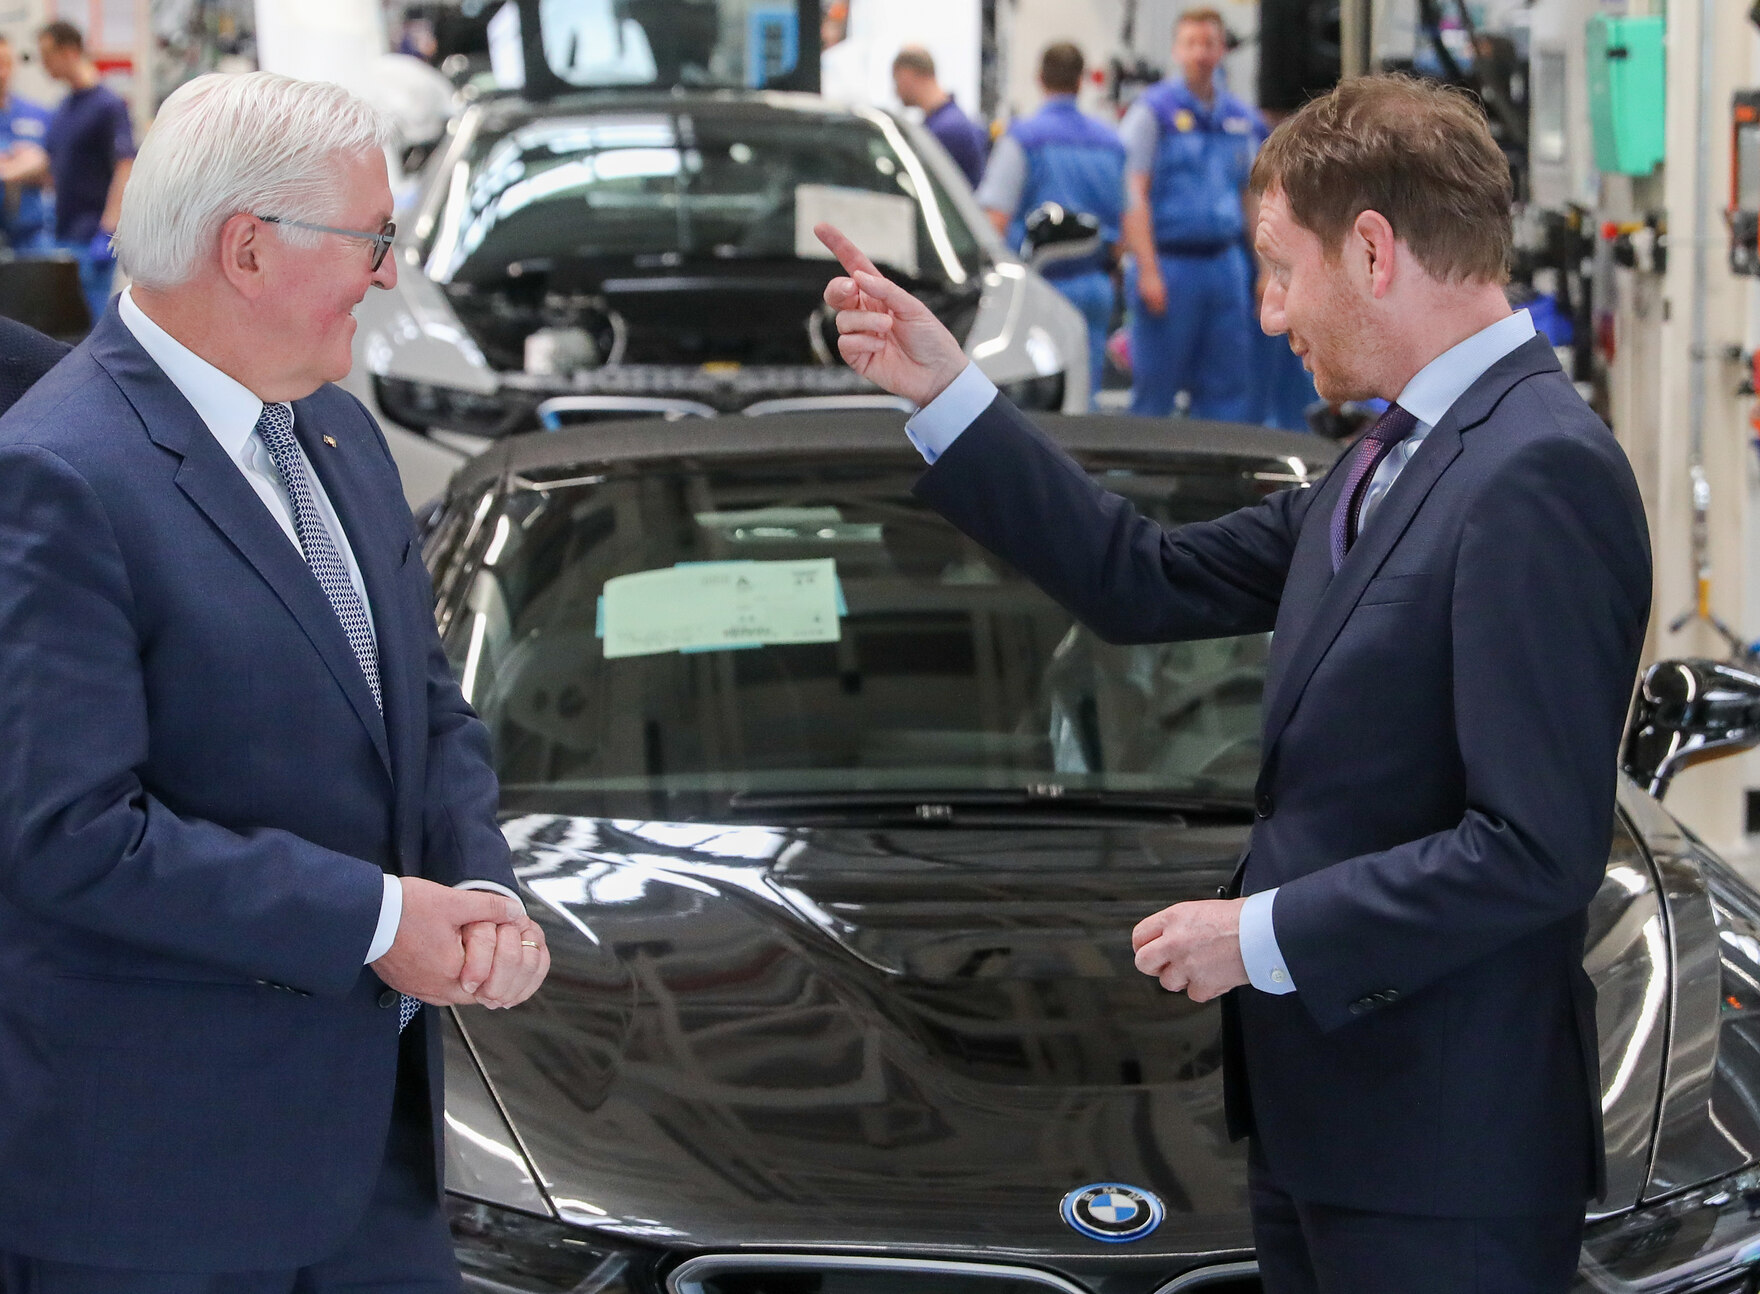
917,338,1651,1217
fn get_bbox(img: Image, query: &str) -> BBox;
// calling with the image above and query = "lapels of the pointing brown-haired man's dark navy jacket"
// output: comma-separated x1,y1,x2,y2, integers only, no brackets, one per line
1264,336,1558,755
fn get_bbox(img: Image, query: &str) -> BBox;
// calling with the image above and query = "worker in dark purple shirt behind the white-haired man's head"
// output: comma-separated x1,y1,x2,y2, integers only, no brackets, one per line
37,21,134,322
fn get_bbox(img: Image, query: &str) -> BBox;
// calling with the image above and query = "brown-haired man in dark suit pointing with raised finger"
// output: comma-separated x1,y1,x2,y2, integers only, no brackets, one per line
822,77,1651,1294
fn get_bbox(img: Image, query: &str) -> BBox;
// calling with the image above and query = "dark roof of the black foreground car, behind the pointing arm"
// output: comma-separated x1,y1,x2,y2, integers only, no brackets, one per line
452,410,1338,489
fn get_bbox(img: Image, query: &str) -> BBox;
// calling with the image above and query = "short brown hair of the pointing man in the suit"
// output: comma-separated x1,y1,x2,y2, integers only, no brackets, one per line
1250,76,1514,283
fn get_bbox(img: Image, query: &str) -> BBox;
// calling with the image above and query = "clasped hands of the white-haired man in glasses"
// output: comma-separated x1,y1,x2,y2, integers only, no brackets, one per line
373,877,549,1009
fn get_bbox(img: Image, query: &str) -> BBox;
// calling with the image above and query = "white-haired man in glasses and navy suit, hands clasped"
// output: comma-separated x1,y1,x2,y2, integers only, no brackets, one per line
0,72,549,1294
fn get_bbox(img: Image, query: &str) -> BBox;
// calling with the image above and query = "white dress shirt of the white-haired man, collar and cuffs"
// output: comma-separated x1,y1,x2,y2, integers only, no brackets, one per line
116,287,517,961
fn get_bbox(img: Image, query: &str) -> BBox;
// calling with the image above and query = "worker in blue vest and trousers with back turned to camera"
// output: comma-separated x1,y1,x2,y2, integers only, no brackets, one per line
979,40,1125,401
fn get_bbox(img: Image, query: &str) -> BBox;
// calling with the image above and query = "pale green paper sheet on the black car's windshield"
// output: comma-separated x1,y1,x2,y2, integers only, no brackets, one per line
605,556,841,660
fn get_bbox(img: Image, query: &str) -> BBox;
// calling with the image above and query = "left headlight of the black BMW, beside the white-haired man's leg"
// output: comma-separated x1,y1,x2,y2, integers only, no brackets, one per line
445,1195,646,1294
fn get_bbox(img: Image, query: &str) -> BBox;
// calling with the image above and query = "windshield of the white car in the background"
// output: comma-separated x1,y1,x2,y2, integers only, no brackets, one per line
424,106,979,285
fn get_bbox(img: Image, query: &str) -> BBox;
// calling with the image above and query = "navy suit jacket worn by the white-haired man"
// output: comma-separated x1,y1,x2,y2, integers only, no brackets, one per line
0,306,512,1271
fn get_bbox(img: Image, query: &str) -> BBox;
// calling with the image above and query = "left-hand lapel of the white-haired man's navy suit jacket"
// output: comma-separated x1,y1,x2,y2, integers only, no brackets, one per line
92,308,391,775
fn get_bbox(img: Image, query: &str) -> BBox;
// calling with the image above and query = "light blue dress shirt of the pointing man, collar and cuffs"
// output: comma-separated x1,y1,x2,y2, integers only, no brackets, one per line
905,310,1535,993
